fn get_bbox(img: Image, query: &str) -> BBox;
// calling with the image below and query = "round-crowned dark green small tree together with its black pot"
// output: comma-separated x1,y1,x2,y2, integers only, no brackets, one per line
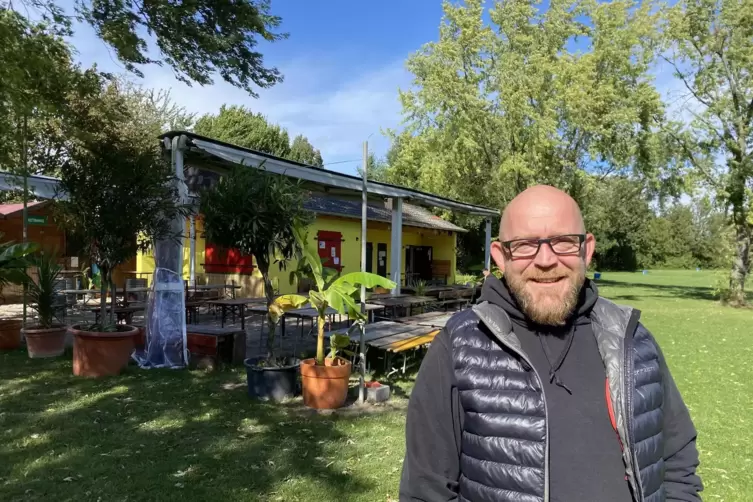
200,166,313,401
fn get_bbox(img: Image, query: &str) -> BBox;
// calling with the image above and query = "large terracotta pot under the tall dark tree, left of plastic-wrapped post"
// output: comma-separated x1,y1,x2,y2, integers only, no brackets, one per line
69,324,139,377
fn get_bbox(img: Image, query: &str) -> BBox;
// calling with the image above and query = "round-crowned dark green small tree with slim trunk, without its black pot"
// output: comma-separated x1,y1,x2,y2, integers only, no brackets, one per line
200,167,313,366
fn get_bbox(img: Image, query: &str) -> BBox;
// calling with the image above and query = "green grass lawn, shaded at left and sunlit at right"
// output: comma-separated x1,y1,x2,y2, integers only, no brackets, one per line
0,271,753,502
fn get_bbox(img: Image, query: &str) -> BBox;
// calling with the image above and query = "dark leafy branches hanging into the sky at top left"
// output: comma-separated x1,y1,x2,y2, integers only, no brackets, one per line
0,0,288,97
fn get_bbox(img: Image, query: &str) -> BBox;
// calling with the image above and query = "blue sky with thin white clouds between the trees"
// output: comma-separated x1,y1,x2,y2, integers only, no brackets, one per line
63,0,680,173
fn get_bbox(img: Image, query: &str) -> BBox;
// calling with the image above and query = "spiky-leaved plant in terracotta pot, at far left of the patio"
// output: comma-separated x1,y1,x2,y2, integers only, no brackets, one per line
21,252,67,358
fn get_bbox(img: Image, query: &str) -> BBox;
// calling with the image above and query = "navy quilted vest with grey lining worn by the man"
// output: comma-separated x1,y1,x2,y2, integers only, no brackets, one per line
446,298,665,502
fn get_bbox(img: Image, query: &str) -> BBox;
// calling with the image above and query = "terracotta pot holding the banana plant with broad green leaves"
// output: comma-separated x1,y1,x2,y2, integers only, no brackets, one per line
301,358,351,410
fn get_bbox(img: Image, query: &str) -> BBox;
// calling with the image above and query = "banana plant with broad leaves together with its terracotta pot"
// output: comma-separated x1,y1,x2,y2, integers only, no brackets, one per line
288,229,395,409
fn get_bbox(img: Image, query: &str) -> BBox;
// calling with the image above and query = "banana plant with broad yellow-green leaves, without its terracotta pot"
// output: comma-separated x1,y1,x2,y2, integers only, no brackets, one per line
274,227,395,366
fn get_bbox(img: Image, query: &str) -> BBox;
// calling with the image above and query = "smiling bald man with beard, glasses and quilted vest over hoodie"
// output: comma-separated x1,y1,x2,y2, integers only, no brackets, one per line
400,186,702,502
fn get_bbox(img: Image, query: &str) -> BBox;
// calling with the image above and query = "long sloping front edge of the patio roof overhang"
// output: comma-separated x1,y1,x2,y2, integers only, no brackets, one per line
160,131,499,217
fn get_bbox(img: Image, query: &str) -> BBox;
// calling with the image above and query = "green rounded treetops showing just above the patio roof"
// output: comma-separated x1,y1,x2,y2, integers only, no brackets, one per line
194,105,324,167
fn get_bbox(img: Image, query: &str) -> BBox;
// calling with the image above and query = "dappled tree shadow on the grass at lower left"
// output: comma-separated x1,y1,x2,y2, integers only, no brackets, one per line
0,352,373,501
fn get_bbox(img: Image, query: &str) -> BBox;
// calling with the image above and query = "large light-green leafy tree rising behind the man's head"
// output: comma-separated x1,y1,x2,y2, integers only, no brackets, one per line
389,0,663,207
